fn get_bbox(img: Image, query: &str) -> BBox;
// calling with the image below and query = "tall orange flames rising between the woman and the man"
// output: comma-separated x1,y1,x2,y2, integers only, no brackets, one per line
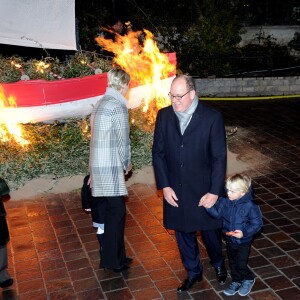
96,29,175,123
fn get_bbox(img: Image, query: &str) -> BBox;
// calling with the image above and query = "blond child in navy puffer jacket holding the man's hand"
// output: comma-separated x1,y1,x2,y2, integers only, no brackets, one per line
206,174,263,296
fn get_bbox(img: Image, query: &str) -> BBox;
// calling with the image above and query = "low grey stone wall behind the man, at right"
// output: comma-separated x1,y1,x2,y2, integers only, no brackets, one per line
195,76,300,97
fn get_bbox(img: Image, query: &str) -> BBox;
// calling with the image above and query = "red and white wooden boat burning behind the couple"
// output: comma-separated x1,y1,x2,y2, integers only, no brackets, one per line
0,53,176,123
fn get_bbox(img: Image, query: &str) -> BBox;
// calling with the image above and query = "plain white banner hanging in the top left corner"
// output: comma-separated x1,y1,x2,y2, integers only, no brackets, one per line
0,0,76,50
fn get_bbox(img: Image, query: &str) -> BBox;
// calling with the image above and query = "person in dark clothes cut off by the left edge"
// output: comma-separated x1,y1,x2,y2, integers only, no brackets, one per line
0,178,14,289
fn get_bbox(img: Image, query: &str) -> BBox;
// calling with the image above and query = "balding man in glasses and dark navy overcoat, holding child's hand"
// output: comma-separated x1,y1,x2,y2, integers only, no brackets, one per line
152,75,227,292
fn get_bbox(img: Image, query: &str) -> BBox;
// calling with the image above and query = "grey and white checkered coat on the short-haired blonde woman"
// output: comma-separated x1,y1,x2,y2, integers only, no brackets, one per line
89,88,131,197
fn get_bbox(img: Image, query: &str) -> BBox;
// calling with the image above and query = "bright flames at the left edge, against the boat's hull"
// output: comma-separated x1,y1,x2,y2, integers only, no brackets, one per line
0,85,29,147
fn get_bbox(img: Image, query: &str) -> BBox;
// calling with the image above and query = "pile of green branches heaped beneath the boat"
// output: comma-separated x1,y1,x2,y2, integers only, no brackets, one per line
0,109,153,189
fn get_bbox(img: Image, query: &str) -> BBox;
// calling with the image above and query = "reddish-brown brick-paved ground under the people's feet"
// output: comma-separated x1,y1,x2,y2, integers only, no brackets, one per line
0,99,300,300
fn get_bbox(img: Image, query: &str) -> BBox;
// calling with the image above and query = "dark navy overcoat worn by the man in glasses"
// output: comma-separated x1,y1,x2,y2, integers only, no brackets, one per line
152,101,227,233
